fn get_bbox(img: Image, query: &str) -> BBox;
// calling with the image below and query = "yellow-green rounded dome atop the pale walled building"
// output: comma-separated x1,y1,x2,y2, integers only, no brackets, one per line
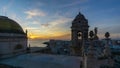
0,16,24,34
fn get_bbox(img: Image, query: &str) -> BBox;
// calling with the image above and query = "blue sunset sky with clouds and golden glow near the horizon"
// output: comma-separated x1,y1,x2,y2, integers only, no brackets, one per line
0,0,120,39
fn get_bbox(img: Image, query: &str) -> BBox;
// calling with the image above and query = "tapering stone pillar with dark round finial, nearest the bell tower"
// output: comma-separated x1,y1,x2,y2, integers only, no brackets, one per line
86,31,99,68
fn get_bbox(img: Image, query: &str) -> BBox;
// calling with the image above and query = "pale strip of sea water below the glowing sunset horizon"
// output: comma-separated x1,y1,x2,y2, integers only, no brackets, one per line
28,39,49,47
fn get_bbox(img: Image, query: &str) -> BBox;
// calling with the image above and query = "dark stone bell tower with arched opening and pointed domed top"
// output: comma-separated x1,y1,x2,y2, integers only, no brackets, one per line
71,12,89,56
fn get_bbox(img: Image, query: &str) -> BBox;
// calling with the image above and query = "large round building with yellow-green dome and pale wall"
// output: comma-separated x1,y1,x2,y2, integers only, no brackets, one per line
0,16,27,58
